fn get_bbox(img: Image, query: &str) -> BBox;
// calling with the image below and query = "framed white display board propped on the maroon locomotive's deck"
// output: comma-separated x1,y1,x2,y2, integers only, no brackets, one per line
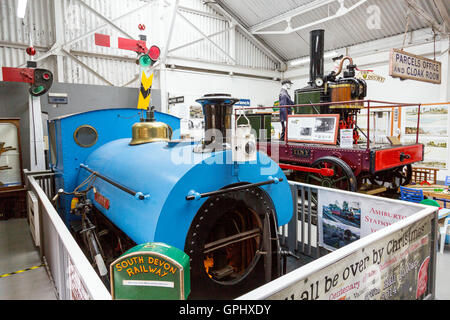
286,114,339,144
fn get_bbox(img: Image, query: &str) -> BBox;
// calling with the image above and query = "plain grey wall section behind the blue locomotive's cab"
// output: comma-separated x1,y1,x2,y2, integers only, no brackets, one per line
0,82,161,169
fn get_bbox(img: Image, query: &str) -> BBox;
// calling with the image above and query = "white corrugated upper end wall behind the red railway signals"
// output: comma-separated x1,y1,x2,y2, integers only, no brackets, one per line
0,0,282,87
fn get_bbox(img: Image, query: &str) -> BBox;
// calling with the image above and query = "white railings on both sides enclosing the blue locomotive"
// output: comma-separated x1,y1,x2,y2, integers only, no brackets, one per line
24,170,438,300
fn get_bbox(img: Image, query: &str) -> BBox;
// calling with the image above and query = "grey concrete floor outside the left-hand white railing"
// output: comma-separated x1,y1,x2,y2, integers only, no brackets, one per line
0,219,56,300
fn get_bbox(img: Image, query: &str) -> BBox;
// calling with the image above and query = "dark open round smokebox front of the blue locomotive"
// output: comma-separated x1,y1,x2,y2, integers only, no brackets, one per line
184,188,280,299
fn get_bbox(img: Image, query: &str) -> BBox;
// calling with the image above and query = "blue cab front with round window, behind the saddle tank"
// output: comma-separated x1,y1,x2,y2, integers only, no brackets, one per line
49,108,180,225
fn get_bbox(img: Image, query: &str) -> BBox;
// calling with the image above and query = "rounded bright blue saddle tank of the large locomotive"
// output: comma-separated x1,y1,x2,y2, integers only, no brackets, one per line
77,139,293,250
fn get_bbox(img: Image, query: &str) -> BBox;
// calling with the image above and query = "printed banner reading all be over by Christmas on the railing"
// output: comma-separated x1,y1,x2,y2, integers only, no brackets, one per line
267,215,433,300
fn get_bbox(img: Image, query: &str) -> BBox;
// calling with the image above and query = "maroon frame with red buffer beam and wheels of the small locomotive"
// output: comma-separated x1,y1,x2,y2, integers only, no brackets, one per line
258,141,424,193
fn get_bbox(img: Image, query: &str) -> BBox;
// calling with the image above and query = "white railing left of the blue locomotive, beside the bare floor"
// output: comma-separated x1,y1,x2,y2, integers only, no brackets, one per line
24,170,111,300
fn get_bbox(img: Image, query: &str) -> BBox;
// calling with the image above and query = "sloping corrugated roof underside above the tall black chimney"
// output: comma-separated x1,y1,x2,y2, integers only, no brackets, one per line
216,0,450,61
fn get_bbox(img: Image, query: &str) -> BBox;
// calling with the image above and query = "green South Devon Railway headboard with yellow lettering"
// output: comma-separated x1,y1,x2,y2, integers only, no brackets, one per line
110,242,191,300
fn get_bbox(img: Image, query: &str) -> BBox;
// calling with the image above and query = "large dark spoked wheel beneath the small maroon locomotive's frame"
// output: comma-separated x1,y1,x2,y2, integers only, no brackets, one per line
306,157,358,192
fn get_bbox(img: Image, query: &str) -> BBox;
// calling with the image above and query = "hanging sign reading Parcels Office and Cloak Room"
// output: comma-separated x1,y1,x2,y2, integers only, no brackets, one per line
389,49,441,84
